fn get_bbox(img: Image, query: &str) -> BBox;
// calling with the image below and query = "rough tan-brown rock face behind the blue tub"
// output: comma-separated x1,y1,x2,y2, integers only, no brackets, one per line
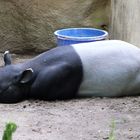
0,0,110,54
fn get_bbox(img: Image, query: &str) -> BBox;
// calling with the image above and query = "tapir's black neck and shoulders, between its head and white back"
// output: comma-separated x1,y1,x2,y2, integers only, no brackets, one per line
28,46,83,100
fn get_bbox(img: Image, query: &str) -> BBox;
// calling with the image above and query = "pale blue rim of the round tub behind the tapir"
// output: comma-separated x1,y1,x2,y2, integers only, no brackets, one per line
54,28,108,41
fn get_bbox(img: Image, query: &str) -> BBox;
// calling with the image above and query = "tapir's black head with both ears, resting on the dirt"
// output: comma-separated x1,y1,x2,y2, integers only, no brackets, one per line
0,52,33,103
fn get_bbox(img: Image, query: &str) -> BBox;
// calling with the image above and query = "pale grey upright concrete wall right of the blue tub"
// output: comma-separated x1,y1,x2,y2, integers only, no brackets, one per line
110,0,140,47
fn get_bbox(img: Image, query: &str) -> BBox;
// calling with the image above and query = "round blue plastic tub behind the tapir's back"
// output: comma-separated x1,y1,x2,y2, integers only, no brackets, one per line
54,28,108,46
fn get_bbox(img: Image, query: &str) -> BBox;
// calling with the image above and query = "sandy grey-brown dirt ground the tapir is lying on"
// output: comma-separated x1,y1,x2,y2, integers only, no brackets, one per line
0,55,140,140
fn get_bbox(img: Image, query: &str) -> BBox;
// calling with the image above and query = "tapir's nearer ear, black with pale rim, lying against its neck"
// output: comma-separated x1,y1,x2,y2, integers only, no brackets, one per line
19,68,33,84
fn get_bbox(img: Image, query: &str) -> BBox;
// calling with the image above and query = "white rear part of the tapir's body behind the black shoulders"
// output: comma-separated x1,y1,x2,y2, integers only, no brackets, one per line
72,40,140,96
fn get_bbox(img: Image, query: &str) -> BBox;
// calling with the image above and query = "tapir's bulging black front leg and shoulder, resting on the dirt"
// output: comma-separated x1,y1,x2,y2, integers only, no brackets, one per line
30,63,82,100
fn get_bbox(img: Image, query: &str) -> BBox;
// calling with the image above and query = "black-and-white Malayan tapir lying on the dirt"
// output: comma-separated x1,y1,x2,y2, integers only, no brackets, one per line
0,40,140,103
